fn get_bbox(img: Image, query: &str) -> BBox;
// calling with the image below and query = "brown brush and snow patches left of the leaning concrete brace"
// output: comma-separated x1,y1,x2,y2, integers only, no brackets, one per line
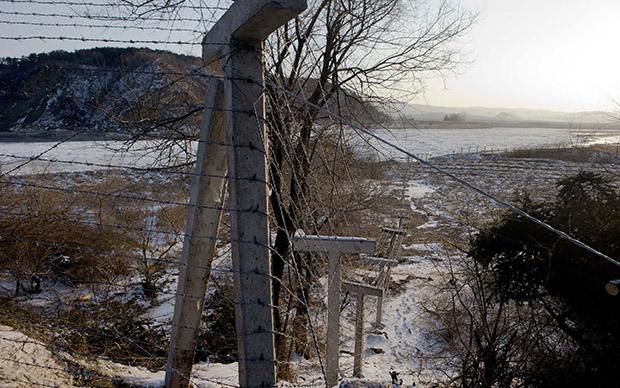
0,172,186,368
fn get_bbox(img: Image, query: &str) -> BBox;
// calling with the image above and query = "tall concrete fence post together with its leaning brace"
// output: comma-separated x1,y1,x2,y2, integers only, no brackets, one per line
166,0,306,387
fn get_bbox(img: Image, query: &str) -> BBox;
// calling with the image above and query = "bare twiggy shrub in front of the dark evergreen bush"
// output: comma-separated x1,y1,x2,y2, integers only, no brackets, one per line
426,258,544,388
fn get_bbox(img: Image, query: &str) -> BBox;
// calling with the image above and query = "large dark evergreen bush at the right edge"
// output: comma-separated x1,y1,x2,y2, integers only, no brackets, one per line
455,172,620,387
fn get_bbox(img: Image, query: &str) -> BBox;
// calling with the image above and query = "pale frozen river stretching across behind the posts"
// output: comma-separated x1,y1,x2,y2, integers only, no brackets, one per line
0,128,620,174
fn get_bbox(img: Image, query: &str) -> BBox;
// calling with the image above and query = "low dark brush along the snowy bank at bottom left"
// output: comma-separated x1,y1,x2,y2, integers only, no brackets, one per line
0,296,168,372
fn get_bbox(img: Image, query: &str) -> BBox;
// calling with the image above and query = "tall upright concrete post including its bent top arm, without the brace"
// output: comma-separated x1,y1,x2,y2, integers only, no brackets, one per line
208,0,306,387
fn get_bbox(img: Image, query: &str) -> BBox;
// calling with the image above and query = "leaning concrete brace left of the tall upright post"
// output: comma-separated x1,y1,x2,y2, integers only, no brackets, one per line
166,79,227,387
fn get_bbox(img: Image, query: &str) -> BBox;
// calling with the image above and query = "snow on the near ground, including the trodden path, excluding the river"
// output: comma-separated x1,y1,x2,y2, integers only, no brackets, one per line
0,154,620,387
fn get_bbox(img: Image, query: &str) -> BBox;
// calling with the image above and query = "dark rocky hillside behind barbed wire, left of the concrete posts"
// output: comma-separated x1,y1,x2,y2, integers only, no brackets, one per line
0,48,206,132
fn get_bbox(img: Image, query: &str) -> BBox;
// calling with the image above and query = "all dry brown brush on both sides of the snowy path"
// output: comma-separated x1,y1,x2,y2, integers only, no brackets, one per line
0,140,620,386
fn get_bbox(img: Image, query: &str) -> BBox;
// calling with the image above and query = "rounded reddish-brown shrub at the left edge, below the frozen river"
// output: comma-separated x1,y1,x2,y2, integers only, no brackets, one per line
0,183,131,294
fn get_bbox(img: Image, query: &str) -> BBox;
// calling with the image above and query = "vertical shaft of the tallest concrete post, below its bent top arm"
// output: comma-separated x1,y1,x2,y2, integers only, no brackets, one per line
225,40,276,387
